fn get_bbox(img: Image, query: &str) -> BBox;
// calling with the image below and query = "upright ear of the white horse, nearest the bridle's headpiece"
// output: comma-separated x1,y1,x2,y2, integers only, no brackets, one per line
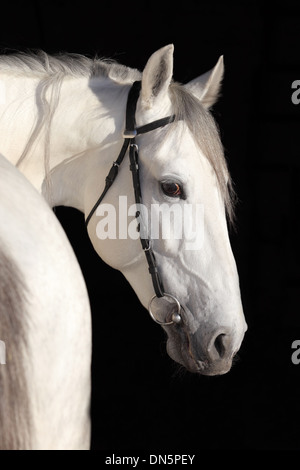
141,44,174,108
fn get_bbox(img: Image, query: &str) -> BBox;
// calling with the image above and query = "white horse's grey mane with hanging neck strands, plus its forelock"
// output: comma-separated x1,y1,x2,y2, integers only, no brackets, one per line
0,51,234,223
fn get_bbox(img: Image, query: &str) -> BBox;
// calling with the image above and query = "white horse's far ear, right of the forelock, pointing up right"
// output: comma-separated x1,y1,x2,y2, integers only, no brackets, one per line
185,56,224,108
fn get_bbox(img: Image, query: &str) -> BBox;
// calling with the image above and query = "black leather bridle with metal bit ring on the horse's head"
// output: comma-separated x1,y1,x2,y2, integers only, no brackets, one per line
85,81,182,326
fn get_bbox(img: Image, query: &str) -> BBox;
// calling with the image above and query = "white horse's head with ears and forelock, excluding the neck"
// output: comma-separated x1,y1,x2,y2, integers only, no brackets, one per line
89,45,247,375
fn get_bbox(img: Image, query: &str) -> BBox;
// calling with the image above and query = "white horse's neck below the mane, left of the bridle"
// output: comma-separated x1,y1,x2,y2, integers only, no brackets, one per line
0,75,126,211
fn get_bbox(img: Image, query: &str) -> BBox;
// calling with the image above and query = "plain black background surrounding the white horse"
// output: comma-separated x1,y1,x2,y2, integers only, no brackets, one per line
0,0,300,452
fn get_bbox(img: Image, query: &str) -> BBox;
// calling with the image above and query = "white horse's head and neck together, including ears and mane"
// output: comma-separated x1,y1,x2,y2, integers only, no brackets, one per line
0,45,247,375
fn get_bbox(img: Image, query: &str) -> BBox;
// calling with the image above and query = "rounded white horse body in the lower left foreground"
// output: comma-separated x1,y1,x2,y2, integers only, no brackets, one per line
0,156,91,450
